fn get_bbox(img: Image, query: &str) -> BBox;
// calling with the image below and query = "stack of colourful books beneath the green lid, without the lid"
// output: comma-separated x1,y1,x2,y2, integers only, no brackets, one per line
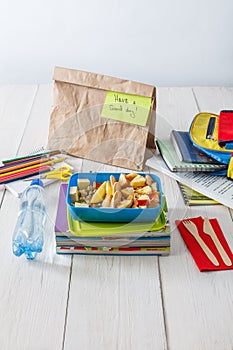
54,184,170,256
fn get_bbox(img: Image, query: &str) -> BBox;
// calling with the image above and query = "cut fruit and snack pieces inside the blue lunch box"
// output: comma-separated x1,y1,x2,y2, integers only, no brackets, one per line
70,173,160,208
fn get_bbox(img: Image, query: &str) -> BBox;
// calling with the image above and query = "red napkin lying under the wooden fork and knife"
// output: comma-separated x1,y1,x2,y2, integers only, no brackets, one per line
176,216,233,271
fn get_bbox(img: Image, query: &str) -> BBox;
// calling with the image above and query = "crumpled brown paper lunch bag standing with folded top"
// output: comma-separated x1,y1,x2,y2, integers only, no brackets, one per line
48,67,156,170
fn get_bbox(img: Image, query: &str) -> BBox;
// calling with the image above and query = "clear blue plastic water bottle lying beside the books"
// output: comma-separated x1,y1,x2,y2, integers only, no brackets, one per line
12,179,46,260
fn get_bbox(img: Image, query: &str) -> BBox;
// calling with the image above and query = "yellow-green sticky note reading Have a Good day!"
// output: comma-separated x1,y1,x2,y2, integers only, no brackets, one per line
101,91,152,126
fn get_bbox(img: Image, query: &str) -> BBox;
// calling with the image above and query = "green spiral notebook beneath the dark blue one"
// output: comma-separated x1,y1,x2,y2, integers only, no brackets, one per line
156,140,226,172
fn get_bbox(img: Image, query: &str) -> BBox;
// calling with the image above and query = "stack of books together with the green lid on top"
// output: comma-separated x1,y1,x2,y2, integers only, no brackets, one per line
55,184,170,256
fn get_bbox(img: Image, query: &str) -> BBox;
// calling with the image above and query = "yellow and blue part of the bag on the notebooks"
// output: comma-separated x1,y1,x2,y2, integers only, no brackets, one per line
189,112,233,178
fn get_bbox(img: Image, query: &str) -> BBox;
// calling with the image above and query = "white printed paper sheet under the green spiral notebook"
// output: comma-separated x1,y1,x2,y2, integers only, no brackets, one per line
146,155,233,209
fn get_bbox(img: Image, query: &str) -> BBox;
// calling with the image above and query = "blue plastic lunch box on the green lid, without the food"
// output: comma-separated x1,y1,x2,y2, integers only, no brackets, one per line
66,173,162,222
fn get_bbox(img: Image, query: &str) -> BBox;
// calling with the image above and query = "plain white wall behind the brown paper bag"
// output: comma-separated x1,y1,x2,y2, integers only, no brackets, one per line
0,0,233,86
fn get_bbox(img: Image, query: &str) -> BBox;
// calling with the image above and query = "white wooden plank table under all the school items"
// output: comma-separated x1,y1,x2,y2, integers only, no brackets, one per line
0,85,233,350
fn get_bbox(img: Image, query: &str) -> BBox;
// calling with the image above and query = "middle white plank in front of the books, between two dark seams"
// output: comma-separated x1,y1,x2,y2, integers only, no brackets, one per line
64,160,167,350
